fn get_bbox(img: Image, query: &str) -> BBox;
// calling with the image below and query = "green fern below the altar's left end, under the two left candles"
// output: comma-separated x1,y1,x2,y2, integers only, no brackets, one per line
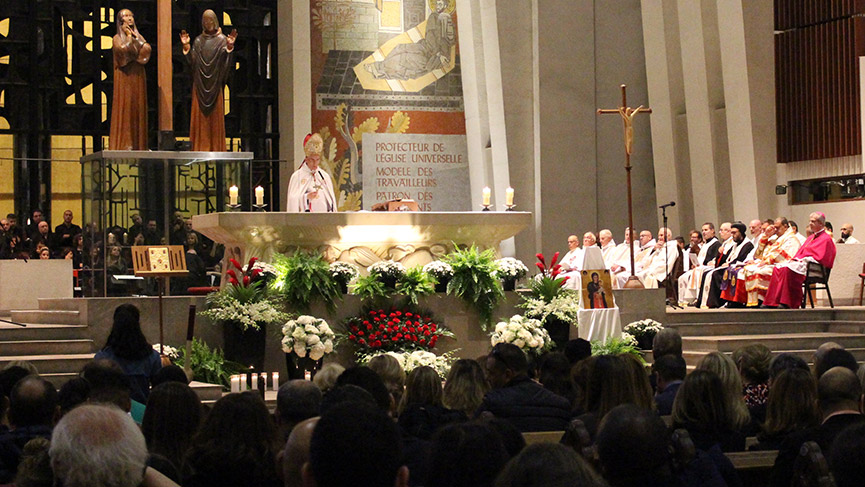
275,250,342,313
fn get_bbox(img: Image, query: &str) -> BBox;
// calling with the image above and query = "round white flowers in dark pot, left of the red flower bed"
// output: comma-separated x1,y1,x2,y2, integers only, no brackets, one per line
282,315,336,379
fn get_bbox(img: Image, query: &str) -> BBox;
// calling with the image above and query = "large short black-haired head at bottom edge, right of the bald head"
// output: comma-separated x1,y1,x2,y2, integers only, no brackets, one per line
306,402,410,487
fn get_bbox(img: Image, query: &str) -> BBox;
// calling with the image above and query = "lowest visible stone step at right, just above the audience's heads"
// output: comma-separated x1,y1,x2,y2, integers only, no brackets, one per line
682,333,865,352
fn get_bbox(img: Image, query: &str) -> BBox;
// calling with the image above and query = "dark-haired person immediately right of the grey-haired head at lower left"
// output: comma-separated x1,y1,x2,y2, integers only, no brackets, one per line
141,382,203,472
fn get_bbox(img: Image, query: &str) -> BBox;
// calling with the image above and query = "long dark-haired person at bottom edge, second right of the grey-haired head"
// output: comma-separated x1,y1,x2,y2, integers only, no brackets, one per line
182,391,280,487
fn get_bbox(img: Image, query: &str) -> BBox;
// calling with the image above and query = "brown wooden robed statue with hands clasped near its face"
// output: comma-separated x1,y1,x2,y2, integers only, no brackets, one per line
108,9,151,150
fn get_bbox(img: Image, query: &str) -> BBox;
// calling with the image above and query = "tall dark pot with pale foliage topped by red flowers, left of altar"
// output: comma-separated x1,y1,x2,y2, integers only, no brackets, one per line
199,257,288,370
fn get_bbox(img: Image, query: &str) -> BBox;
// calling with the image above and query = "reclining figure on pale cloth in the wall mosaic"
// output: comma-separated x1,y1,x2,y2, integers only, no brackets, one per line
366,0,456,80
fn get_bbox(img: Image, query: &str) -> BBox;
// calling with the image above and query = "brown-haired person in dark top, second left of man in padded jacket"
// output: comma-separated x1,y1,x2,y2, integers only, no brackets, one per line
399,366,468,440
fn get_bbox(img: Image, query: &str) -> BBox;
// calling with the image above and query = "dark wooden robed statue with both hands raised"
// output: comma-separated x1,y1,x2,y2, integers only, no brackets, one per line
180,10,237,152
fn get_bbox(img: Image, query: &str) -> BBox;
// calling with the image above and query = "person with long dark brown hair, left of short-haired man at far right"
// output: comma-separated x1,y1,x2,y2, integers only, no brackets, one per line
750,369,820,450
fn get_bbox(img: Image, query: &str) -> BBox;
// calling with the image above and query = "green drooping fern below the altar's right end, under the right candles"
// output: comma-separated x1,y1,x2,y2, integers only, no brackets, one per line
443,245,505,331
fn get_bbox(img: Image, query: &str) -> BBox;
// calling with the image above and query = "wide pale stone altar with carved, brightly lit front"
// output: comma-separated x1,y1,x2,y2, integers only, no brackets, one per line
192,211,532,269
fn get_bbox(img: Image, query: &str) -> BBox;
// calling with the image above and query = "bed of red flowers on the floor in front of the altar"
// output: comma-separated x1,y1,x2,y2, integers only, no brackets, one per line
344,309,454,356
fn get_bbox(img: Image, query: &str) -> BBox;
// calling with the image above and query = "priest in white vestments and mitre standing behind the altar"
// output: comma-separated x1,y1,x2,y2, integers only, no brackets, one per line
286,134,336,213
